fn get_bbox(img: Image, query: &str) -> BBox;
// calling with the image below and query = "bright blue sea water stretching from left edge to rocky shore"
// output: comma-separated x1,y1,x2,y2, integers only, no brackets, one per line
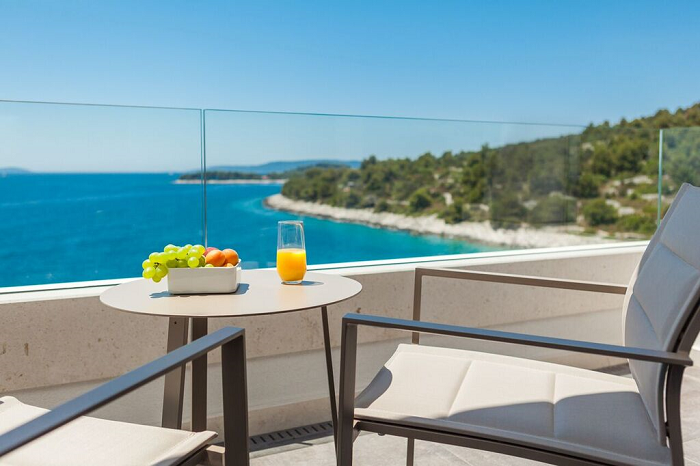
0,174,493,287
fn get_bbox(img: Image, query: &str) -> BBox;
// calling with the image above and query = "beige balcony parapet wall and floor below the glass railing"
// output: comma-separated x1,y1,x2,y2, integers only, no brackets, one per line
5,243,700,465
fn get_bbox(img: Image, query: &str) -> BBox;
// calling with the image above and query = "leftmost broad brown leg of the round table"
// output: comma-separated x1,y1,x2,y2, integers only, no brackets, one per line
162,317,189,429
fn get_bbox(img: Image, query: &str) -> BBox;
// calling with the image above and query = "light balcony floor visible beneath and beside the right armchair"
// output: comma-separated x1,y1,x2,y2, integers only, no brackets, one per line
251,366,700,466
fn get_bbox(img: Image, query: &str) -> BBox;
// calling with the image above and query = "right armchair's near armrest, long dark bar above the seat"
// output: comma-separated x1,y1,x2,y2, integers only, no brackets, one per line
343,314,693,366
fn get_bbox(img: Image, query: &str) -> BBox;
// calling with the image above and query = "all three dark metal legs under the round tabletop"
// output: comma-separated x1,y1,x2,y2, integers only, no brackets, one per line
162,306,338,448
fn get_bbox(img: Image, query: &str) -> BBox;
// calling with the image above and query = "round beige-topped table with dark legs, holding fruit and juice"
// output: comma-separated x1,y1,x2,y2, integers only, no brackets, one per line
100,269,362,440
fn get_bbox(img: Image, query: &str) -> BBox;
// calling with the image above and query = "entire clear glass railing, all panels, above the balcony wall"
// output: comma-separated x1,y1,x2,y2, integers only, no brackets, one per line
0,102,672,287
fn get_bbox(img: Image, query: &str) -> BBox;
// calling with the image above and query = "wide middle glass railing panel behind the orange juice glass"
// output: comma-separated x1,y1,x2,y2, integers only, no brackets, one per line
206,111,636,267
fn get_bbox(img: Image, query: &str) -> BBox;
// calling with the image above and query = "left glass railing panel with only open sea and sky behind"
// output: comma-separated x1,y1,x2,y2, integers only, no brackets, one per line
0,102,204,287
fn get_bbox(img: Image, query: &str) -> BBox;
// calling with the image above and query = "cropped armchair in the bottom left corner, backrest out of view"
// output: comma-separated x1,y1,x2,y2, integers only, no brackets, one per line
0,327,249,466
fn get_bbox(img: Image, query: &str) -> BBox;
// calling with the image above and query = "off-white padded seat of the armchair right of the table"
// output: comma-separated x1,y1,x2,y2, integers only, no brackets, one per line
355,345,671,465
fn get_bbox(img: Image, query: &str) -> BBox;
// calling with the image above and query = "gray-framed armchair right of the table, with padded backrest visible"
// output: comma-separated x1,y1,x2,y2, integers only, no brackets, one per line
338,184,700,466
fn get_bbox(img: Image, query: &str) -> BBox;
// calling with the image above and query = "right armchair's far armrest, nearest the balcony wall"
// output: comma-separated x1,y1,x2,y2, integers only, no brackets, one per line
416,267,627,294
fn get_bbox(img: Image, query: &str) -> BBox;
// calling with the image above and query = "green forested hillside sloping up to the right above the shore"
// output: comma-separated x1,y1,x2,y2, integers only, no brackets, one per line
282,104,700,236
